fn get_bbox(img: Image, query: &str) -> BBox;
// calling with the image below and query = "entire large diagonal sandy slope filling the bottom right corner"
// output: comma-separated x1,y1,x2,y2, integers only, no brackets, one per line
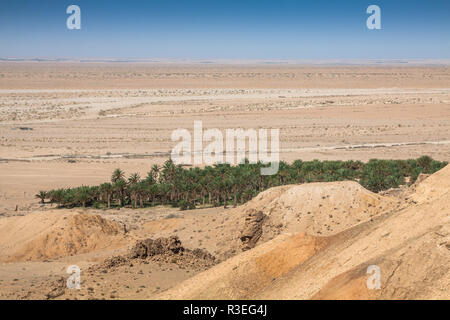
160,166,450,299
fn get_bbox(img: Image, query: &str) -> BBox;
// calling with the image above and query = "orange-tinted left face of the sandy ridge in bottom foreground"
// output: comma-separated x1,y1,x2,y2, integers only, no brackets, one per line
157,233,327,299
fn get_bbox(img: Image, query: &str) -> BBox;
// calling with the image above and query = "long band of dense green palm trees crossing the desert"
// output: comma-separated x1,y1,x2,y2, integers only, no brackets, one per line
36,156,447,210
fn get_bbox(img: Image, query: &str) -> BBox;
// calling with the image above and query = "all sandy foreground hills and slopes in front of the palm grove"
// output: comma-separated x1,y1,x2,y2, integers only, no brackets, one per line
0,166,450,299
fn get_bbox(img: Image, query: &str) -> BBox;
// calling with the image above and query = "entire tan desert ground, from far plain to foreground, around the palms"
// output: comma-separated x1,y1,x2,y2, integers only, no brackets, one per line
0,61,450,299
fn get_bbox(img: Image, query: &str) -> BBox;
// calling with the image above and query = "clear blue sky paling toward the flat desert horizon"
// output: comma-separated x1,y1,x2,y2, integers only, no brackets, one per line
0,0,450,59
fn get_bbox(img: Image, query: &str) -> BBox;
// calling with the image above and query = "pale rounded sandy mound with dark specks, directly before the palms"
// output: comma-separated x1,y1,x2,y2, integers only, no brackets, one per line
241,181,396,236
